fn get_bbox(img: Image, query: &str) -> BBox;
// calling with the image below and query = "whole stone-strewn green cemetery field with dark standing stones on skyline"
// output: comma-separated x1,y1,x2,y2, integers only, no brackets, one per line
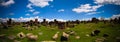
0,18,120,42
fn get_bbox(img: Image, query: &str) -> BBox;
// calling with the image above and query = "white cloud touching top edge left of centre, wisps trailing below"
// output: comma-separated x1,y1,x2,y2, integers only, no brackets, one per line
26,0,53,15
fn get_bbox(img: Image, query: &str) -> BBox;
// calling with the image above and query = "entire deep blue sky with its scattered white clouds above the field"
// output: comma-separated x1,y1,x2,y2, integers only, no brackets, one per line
0,0,120,20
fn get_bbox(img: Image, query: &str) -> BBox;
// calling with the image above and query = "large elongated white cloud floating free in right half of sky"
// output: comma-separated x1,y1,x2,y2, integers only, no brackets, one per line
72,4,102,13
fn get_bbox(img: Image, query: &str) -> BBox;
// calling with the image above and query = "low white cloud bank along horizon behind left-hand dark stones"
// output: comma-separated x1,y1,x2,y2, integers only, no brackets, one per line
0,16,66,22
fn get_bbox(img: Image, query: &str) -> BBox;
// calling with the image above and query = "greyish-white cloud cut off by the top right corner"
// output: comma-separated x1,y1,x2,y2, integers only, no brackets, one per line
94,0,120,5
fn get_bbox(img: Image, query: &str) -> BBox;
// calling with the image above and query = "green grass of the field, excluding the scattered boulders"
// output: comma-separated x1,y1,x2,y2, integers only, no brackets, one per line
0,22,120,42
